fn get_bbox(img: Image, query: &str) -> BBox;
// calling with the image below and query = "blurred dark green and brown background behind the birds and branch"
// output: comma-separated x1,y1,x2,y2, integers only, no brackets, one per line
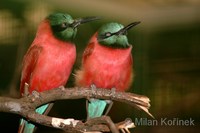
0,0,200,133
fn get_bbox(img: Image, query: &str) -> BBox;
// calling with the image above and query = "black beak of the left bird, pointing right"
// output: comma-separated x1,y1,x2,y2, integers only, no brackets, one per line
70,17,101,28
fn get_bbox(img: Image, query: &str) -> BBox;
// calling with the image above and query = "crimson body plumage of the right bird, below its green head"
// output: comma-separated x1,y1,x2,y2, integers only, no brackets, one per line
76,33,133,91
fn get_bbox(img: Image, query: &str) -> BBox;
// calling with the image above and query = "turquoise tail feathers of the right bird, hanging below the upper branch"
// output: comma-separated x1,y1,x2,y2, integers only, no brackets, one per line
87,99,107,118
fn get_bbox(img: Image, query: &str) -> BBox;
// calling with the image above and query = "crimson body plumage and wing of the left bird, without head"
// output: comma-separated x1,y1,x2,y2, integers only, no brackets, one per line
20,20,76,93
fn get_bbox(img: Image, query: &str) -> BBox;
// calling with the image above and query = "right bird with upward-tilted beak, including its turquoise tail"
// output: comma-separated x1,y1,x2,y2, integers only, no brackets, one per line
75,22,140,118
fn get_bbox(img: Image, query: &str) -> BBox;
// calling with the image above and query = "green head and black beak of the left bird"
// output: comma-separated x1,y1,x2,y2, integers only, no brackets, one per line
47,13,99,41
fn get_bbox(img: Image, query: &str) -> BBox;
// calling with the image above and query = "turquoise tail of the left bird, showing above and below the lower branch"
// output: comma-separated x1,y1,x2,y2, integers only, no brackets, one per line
18,103,53,133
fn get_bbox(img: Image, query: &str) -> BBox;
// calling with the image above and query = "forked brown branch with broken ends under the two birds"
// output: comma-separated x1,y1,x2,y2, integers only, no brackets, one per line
0,87,153,133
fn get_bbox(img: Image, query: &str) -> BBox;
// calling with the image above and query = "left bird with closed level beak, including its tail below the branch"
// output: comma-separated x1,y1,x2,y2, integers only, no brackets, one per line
18,13,99,133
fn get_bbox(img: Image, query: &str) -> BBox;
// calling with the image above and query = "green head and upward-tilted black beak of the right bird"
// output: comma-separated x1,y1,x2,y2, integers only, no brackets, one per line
97,22,140,48
